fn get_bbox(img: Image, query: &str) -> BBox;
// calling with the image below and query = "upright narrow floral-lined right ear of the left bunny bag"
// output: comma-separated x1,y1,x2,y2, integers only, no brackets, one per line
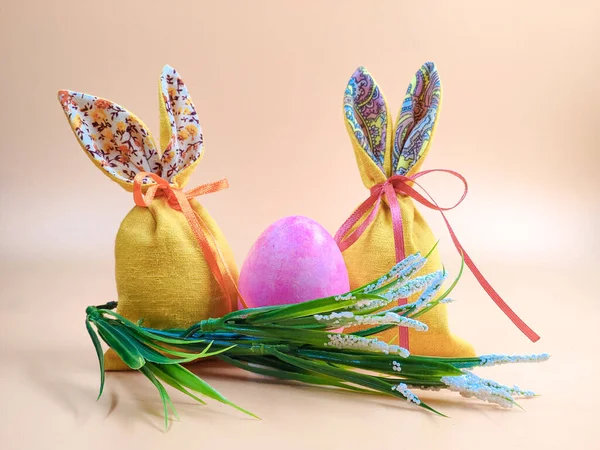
159,65,204,186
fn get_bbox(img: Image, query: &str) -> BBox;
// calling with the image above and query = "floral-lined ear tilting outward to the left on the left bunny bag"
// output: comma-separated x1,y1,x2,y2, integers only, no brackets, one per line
58,90,160,190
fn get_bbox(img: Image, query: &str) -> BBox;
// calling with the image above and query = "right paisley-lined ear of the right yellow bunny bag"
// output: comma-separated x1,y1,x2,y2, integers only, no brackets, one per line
392,62,442,175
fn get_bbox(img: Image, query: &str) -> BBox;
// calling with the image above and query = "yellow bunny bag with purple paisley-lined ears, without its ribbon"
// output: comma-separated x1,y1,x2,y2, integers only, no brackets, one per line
343,62,475,357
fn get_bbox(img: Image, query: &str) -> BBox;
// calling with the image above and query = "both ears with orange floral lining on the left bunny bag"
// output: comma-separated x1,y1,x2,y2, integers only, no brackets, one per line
58,66,203,183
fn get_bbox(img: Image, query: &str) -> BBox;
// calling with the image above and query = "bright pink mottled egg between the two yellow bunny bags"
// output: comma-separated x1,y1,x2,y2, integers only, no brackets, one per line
239,216,350,308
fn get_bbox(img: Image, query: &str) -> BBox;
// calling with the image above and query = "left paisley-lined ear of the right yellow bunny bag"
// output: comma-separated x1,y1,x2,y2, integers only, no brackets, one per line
344,67,391,172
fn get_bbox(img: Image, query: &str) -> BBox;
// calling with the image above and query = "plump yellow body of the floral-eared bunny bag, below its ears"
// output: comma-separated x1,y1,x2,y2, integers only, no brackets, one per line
106,198,238,370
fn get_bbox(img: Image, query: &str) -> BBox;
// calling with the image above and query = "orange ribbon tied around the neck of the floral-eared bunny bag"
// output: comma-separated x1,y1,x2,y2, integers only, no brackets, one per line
133,172,247,311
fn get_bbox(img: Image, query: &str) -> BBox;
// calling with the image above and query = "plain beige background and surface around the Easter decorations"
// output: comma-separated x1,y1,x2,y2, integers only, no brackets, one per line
0,0,600,449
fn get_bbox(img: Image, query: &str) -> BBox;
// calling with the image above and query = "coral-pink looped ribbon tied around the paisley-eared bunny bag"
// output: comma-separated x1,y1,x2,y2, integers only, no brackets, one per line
335,169,540,348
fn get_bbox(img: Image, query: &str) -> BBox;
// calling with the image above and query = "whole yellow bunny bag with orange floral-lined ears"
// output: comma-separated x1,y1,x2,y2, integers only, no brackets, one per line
59,66,238,370
